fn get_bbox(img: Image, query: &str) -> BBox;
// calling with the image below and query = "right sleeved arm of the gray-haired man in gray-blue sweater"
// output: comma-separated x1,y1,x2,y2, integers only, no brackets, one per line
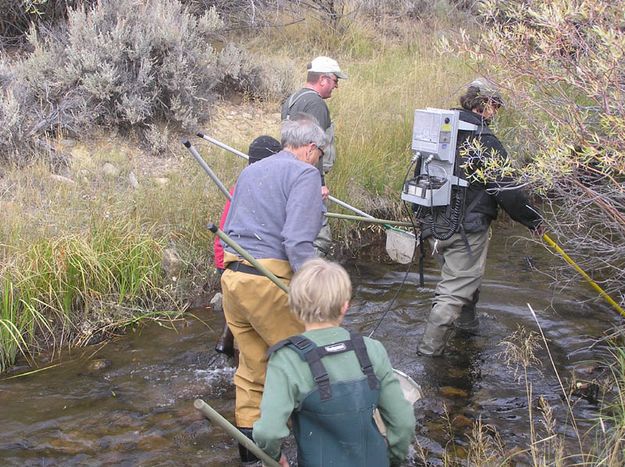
282,166,323,271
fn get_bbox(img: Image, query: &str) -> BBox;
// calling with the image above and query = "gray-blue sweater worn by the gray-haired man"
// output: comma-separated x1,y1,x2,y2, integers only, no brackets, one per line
224,150,325,271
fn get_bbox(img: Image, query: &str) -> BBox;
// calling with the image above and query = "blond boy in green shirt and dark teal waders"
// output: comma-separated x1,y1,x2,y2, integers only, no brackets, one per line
253,259,415,467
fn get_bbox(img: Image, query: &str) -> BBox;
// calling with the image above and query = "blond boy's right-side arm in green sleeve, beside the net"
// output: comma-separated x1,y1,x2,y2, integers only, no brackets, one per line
370,341,416,465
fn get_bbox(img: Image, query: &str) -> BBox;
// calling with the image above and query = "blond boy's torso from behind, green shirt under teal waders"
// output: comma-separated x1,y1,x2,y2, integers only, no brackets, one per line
255,327,398,467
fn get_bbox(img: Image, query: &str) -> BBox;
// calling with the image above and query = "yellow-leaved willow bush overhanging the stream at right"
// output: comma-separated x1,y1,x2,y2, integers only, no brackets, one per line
450,0,625,305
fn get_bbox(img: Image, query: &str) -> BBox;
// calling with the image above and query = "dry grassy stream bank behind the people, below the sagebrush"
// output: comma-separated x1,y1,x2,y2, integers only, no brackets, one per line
0,10,470,369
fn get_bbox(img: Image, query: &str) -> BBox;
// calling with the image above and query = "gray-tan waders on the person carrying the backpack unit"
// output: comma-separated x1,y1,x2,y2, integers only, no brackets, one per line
418,229,490,356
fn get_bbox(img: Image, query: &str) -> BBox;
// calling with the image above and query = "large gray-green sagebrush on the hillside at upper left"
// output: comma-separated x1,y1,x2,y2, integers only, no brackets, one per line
0,0,282,165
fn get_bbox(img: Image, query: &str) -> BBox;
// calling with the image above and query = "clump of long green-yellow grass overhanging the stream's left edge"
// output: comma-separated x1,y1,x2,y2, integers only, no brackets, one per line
0,224,165,371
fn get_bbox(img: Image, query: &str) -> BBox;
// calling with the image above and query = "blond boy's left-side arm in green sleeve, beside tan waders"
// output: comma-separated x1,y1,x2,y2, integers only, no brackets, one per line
252,350,295,460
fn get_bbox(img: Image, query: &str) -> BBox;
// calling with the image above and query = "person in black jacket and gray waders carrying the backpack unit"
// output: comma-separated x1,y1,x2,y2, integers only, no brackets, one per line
417,79,542,356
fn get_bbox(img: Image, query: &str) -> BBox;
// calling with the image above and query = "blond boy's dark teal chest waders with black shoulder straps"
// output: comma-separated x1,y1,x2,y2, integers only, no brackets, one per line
270,333,389,467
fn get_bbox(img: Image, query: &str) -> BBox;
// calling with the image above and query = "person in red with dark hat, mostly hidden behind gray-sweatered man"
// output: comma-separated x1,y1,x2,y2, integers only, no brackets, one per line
213,135,282,357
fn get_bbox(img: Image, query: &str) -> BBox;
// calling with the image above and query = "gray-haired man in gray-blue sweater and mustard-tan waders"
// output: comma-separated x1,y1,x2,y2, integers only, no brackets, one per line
221,115,326,465
